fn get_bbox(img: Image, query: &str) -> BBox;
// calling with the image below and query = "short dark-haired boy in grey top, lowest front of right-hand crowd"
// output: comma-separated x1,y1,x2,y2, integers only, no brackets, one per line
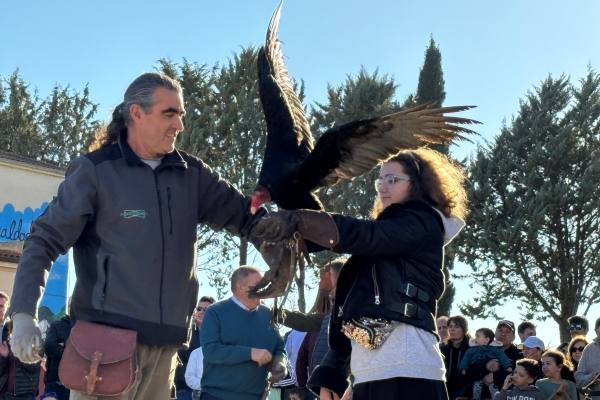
494,358,546,400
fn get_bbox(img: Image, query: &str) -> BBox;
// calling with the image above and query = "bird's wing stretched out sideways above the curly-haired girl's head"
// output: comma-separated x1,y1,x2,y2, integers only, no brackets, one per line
296,105,479,190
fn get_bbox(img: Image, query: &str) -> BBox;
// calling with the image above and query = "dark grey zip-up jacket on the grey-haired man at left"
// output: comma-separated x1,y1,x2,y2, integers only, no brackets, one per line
11,136,252,347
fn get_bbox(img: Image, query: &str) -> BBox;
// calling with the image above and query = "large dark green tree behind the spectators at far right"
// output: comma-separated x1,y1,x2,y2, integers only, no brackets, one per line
459,68,600,341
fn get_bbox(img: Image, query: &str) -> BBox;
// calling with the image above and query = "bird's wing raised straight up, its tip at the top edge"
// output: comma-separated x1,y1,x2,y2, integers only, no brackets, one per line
258,3,314,186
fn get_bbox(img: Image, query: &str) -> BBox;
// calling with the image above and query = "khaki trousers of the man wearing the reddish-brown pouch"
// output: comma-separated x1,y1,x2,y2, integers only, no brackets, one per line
69,343,177,400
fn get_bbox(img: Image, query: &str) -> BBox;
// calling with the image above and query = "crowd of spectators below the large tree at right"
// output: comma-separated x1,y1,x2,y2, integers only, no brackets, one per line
437,315,600,400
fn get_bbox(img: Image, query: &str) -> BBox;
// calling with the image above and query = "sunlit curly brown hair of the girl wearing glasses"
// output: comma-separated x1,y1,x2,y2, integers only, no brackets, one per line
371,147,467,219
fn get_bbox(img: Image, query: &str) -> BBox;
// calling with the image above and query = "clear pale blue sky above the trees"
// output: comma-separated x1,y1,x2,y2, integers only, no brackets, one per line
0,0,600,344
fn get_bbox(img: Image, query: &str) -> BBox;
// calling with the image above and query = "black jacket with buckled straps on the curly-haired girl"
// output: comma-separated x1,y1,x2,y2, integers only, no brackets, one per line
308,201,444,396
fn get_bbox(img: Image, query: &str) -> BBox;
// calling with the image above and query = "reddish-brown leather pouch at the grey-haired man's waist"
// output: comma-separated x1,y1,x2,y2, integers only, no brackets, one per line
58,321,137,396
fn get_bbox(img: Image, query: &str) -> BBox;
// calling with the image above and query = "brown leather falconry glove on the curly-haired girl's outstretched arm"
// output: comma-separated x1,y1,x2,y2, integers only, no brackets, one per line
252,210,339,249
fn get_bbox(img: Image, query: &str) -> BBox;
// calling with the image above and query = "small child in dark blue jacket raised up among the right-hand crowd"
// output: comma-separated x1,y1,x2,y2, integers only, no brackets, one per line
459,328,512,400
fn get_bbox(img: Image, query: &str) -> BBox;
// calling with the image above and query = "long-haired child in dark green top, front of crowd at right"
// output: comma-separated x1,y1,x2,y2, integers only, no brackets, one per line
535,350,578,400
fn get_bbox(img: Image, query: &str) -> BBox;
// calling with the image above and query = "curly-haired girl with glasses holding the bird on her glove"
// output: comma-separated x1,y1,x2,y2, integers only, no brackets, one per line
253,148,466,400
